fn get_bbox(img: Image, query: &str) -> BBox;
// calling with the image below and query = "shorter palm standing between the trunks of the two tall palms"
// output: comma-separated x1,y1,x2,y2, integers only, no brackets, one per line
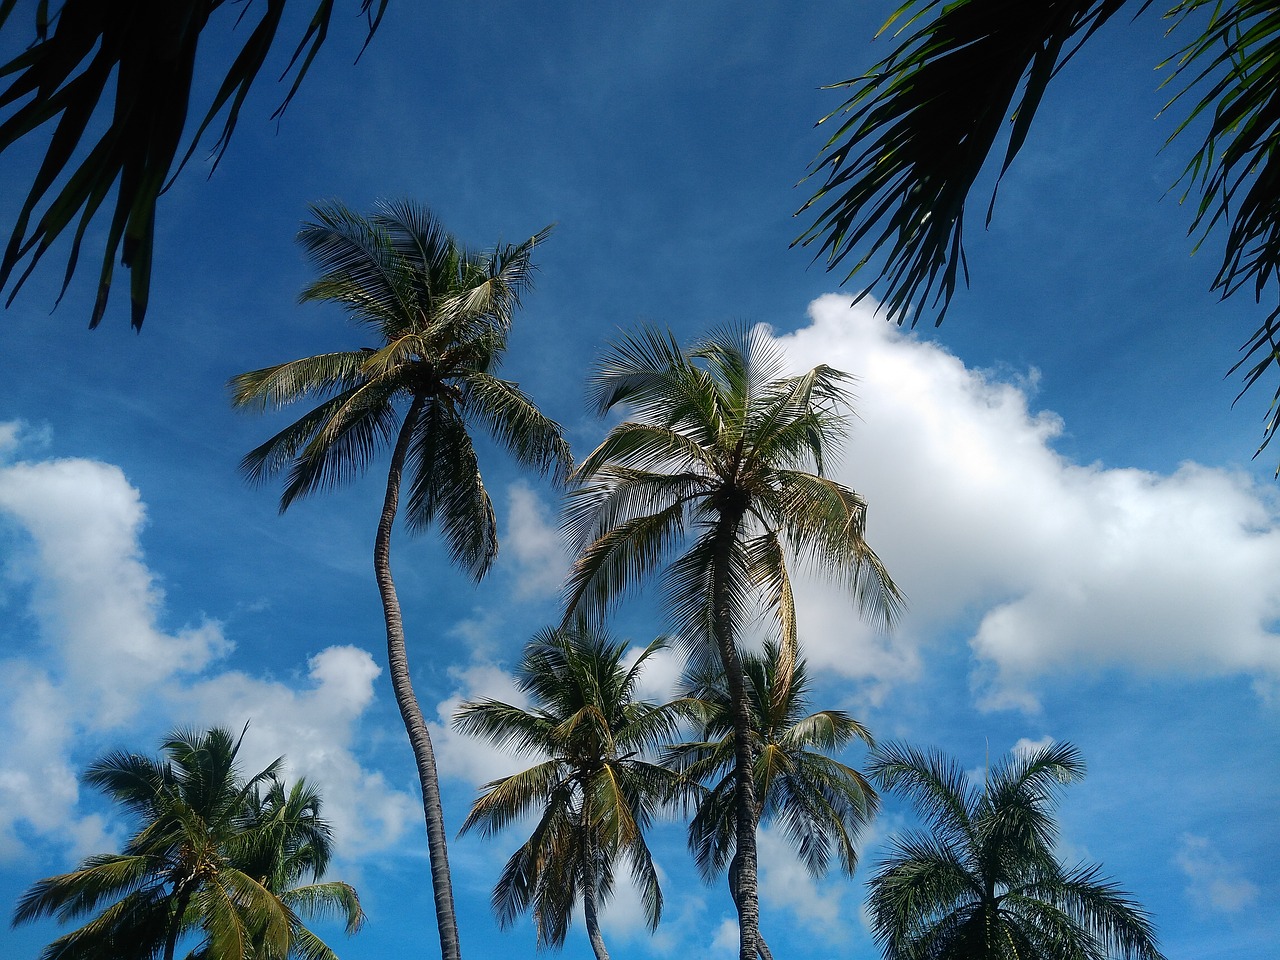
453,630,681,960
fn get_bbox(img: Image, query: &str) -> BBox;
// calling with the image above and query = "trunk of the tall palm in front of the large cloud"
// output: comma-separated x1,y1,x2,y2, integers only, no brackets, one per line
712,507,760,960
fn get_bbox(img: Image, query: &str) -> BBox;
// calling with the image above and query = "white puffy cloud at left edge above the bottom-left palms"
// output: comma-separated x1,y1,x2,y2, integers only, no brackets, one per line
0,435,416,858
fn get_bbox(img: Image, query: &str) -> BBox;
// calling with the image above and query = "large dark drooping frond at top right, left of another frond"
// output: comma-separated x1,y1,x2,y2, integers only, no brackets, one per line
794,0,1149,325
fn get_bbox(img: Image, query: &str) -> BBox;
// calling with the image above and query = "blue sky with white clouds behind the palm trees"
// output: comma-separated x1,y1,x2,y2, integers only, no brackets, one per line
0,0,1280,960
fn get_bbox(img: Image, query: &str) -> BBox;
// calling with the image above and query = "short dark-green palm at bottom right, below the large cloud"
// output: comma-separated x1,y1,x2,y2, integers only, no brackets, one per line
868,744,1164,960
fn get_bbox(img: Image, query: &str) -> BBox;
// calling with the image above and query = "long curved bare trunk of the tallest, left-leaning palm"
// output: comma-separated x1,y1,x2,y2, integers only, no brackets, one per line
374,396,462,960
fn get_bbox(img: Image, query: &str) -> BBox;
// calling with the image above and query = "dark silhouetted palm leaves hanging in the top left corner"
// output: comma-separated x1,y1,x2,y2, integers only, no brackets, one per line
0,0,387,329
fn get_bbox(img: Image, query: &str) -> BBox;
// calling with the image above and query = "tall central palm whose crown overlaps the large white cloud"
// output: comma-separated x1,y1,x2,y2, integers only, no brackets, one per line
566,328,901,960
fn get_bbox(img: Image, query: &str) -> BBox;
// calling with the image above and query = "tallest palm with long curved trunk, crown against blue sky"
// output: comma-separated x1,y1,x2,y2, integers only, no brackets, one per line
230,202,570,960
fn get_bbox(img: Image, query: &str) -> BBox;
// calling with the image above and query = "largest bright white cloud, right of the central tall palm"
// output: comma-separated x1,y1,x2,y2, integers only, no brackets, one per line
781,296,1280,709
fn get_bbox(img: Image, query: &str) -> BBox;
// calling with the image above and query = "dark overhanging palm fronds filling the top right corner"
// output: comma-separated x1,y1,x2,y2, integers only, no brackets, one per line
795,0,1280,463
